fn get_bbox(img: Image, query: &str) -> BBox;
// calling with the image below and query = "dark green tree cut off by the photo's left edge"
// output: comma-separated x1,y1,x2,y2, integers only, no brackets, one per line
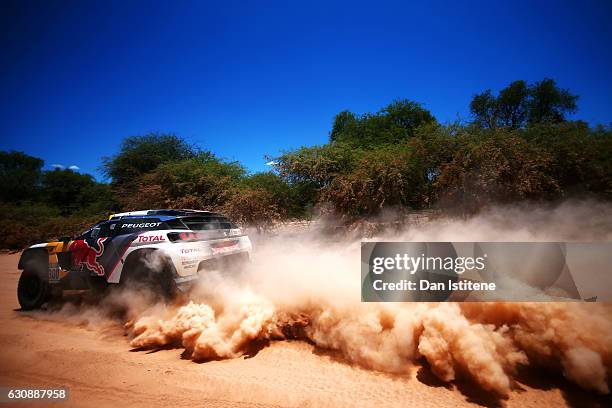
0,151,44,202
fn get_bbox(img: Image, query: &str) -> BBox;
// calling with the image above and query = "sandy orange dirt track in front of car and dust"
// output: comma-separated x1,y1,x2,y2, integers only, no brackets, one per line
0,254,609,408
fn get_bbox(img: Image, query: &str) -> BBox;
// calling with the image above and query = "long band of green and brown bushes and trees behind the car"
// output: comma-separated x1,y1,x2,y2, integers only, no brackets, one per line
0,88,612,249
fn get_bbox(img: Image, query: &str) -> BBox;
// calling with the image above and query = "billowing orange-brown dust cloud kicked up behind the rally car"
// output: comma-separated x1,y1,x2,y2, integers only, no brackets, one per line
39,202,612,396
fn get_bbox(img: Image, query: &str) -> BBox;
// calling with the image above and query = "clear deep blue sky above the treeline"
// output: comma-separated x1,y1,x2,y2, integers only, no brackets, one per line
0,0,612,178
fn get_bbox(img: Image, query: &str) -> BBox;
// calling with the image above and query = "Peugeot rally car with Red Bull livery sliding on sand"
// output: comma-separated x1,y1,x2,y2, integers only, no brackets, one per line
17,210,251,310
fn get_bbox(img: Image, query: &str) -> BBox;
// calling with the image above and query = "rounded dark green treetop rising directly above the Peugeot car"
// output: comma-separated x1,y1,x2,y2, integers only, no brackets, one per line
102,133,197,185
